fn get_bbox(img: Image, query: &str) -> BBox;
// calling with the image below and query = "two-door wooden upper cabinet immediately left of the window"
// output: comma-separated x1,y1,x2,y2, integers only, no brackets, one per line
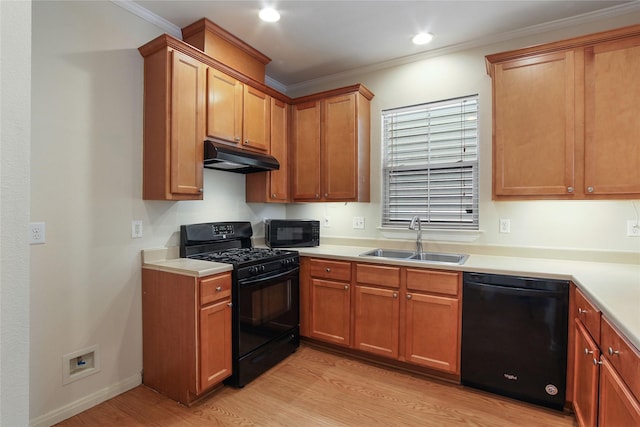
290,85,373,202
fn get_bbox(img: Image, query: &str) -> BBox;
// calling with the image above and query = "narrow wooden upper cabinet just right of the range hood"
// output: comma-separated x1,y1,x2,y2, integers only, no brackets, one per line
246,98,289,203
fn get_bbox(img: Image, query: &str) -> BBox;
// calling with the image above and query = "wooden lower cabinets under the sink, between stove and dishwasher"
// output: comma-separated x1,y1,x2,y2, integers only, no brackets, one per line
301,258,462,375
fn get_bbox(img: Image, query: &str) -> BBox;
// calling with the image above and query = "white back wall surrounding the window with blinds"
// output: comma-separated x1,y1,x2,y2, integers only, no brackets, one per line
287,9,640,258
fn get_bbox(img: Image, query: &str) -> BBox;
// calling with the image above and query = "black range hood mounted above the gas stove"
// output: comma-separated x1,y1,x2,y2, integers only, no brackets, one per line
204,139,280,174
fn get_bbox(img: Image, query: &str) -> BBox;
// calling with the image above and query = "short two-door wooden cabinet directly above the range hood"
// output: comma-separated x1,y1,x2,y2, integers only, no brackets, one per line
207,68,271,152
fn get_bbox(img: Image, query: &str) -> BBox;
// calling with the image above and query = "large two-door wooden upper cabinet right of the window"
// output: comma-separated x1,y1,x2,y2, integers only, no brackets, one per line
486,25,640,200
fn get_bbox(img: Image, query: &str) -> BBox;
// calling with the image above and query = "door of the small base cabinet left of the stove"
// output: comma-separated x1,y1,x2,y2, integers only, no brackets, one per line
198,299,232,393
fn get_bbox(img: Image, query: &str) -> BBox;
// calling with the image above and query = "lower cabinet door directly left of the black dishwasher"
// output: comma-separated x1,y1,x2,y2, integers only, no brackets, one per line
405,292,460,374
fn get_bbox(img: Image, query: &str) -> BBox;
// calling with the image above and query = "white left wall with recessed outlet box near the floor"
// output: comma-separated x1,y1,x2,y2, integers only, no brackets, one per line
30,1,284,425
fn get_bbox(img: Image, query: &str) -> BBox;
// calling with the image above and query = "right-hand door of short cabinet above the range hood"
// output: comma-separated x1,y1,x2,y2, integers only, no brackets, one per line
242,85,271,152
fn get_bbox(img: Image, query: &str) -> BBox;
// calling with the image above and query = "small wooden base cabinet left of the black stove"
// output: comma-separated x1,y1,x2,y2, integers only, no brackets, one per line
142,268,232,405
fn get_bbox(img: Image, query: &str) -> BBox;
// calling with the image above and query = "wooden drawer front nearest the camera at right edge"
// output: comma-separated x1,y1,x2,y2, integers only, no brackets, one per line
600,317,640,399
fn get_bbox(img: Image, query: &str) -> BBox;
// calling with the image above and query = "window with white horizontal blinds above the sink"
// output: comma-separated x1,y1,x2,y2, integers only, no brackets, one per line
382,95,478,230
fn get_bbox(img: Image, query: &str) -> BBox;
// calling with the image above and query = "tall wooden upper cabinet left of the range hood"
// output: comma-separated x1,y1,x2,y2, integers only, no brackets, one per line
140,43,207,200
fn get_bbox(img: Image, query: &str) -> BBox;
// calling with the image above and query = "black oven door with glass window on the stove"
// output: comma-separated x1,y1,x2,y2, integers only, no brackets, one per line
236,267,300,357
